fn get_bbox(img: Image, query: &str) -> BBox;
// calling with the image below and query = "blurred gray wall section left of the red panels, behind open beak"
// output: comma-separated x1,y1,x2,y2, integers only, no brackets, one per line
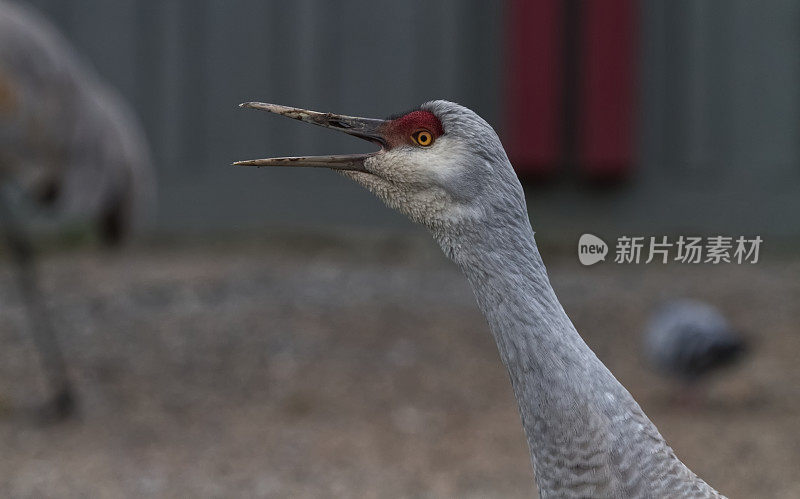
25,0,502,235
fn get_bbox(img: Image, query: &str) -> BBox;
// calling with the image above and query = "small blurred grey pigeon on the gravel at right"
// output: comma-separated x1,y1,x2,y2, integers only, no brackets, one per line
643,299,747,385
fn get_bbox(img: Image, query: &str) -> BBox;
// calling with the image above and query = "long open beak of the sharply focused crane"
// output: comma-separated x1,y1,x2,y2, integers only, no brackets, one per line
234,102,386,172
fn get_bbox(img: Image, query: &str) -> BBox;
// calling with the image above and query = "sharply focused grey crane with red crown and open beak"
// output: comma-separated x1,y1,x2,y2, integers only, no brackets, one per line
235,100,721,498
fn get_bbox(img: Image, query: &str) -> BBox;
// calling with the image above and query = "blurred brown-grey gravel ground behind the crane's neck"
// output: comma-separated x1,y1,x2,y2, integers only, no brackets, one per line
0,239,800,498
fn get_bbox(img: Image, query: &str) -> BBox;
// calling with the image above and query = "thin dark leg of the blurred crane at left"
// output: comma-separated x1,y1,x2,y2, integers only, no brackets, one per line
0,193,76,422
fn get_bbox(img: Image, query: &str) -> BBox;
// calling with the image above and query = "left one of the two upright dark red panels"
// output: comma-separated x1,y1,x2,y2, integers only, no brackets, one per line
504,0,564,177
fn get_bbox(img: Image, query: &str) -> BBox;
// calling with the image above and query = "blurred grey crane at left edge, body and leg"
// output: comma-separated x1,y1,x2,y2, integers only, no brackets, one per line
0,0,154,418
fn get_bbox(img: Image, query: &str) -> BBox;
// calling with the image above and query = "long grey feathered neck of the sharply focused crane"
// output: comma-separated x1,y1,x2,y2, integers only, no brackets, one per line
434,216,705,497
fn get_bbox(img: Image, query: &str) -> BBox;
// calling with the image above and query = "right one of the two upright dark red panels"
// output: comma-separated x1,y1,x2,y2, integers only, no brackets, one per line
578,0,636,180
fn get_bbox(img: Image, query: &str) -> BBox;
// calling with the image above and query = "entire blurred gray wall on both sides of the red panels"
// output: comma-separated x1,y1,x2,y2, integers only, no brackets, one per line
15,0,800,235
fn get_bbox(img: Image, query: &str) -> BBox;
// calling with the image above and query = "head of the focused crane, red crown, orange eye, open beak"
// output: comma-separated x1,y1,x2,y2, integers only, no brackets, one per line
234,100,524,229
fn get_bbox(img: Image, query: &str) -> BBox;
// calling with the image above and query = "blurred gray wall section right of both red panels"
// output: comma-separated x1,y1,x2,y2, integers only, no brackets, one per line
640,0,800,235
